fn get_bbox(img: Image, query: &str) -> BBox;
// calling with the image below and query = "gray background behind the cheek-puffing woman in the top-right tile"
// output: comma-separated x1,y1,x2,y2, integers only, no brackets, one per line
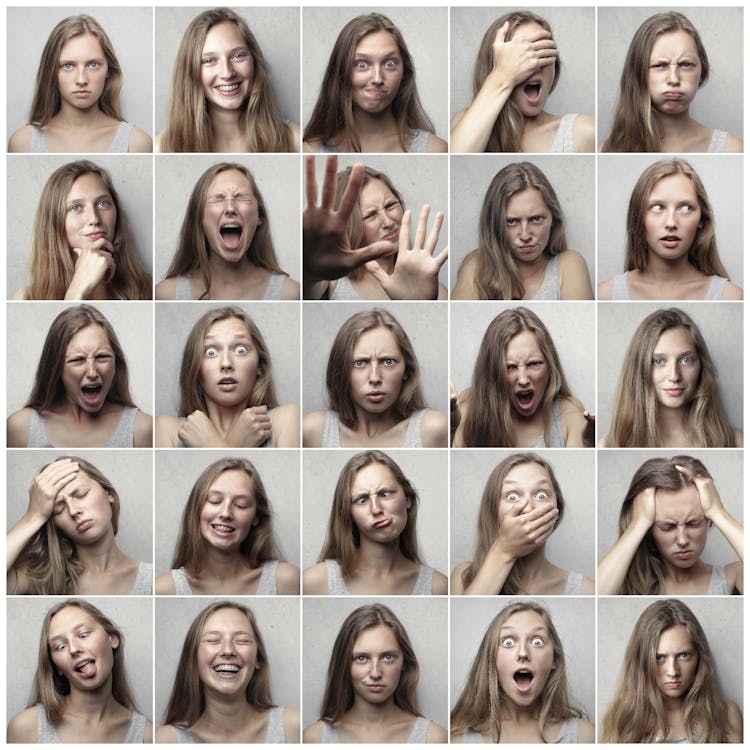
597,6,743,142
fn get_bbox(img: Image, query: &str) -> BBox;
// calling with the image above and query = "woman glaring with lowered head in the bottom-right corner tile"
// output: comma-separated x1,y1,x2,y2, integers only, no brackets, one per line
601,599,742,744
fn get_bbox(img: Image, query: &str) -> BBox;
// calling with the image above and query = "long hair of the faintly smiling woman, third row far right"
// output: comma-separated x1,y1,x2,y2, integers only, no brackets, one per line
605,307,736,448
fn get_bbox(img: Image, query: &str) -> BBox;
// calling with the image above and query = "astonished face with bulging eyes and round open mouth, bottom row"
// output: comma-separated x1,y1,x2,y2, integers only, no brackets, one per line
495,609,555,706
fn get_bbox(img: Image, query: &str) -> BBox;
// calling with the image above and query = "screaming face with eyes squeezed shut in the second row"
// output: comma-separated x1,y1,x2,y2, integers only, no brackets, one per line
202,169,262,263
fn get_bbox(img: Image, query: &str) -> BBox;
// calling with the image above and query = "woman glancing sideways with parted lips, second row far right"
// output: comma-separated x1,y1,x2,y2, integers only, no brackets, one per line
598,158,742,300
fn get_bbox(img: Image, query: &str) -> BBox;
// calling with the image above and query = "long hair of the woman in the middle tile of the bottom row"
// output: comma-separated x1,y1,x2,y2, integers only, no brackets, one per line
320,604,422,724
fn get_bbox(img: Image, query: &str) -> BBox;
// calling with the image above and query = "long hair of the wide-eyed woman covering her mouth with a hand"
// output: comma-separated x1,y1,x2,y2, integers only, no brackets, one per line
461,453,565,596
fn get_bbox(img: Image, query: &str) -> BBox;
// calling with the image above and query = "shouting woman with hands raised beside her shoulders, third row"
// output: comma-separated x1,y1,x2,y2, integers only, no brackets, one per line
451,307,594,448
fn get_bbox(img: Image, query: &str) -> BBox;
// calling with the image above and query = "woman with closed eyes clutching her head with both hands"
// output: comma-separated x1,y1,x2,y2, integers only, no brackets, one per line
597,456,745,596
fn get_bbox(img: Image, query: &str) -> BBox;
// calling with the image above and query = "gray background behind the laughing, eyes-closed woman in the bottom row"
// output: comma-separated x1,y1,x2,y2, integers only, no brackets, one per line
155,596,300,741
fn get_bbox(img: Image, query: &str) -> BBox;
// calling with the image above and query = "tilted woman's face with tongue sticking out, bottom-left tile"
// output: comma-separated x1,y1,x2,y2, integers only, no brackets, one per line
47,606,120,691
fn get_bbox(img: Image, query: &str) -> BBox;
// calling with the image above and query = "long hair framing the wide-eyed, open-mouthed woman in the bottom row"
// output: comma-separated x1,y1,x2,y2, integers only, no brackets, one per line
451,601,583,743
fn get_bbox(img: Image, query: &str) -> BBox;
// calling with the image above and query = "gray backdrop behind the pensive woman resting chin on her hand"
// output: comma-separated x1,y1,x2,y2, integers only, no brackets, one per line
6,154,153,298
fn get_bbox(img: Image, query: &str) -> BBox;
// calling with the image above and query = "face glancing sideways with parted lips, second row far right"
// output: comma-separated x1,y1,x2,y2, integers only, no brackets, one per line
643,174,701,262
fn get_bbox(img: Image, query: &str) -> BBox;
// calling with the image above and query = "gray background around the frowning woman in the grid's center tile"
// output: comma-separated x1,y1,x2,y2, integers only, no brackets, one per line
303,301,448,413
